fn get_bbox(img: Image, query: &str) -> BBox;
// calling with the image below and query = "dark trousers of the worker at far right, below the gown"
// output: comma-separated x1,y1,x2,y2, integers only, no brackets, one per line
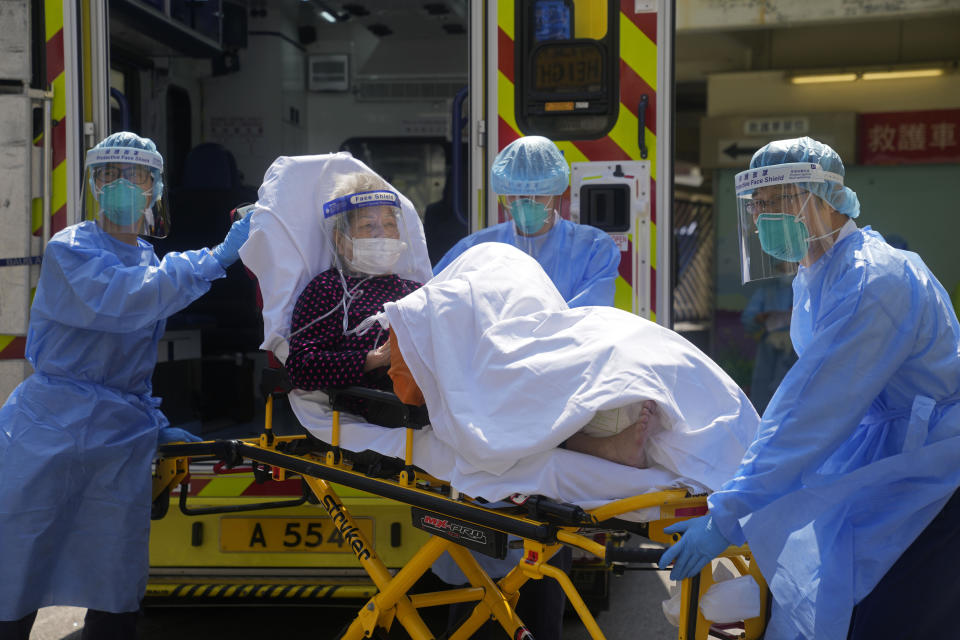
847,490,960,640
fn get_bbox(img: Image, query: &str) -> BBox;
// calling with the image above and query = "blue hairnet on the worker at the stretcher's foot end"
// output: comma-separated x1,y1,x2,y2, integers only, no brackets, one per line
750,136,860,218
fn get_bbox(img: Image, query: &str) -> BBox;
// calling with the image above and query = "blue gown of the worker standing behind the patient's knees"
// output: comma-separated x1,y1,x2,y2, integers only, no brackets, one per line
433,218,620,308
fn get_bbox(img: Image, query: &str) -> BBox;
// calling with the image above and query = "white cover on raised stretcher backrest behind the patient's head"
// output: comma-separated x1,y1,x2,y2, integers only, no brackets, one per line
240,152,432,362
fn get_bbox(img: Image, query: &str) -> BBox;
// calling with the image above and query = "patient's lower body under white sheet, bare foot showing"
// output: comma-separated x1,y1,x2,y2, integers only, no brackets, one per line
385,243,758,487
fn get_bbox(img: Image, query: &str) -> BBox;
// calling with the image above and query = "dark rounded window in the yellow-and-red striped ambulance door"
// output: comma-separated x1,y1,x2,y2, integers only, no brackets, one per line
514,0,620,140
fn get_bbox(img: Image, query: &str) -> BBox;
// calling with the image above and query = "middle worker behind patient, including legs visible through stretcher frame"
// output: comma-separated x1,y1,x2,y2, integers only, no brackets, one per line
433,136,620,640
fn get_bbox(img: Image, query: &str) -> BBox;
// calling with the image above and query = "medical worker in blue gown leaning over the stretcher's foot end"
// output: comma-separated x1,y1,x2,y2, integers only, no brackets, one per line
661,138,960,640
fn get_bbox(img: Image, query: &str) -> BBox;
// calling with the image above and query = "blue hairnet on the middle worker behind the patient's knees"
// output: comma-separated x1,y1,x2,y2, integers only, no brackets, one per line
490,136,570,196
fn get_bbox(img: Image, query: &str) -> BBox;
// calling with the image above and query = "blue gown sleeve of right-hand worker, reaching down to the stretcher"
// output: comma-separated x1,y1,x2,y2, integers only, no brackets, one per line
708,266,920,544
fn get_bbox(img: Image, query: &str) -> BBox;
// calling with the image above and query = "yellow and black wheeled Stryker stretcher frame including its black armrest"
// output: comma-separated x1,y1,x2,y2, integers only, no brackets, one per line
153,376,769,640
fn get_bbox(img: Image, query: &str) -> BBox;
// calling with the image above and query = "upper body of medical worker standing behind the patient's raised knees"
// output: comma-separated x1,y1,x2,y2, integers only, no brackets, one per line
433,136,620,307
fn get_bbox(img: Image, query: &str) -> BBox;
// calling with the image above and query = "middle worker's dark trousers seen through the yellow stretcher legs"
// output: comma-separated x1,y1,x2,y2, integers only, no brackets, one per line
449,547,573,640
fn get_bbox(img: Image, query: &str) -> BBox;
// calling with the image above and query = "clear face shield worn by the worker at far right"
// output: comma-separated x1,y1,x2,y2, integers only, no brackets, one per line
735,162,843,284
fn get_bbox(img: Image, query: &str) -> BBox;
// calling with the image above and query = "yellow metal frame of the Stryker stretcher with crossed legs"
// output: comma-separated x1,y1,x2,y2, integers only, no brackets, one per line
153,396,769,640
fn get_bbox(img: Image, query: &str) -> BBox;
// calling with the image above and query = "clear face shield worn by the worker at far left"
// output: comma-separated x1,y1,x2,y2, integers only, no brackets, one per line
83,147,170,238
